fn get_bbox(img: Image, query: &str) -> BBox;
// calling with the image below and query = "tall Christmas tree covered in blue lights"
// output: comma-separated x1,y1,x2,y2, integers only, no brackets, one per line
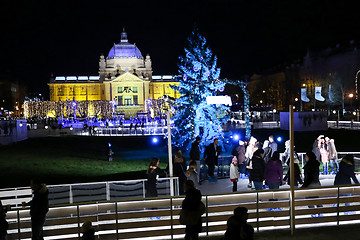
171,29,229,147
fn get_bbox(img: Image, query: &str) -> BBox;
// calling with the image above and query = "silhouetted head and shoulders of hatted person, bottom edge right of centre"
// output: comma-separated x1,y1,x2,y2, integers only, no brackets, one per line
224,207,254,240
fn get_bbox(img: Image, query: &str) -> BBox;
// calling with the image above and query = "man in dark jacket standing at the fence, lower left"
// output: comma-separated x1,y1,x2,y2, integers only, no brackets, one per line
23,179,49,240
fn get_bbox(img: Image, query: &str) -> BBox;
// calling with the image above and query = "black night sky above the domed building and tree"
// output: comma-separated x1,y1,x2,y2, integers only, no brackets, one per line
0,0,360,96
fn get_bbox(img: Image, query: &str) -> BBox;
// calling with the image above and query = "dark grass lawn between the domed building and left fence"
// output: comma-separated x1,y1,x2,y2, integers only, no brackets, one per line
0,137,167,188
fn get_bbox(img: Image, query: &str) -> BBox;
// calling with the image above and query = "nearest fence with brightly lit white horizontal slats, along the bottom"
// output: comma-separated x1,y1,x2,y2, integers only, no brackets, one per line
7,185,360,239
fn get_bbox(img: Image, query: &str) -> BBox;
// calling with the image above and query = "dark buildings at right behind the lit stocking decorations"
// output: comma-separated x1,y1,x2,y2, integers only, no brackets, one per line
248,41,360,111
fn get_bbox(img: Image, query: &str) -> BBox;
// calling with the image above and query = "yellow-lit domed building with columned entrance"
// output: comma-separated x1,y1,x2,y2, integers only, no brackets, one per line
48,31,180,117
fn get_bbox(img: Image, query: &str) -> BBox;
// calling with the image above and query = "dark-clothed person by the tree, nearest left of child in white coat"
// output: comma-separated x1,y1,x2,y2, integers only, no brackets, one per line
204,138,221,182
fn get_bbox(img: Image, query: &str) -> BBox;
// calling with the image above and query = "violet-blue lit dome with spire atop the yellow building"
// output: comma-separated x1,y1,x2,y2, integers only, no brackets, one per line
107,30,144,59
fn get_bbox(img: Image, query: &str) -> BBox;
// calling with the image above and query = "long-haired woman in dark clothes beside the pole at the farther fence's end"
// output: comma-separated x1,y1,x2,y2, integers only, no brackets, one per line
145,157,166,197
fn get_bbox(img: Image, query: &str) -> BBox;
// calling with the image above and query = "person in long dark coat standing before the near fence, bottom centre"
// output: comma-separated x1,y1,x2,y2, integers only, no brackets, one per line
180,180,205,240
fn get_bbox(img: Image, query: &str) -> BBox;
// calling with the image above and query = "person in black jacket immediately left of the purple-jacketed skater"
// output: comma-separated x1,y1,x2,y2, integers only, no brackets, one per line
250,149,265,190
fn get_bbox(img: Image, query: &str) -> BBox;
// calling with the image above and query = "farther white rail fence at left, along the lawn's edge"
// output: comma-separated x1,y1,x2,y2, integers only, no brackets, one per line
0,177,179,207
